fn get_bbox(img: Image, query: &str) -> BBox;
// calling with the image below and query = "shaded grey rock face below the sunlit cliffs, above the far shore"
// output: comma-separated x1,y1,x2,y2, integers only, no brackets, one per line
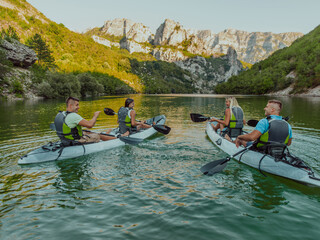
175,47,244,93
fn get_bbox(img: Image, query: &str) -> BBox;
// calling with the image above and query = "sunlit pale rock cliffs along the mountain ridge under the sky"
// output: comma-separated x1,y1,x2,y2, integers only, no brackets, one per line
92,19,303,64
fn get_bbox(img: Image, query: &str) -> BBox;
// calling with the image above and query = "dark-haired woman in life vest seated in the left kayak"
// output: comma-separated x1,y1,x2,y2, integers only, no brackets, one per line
118,98,152,134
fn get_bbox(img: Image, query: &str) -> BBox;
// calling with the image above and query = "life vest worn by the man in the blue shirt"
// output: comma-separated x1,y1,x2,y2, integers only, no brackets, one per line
254,116,289,148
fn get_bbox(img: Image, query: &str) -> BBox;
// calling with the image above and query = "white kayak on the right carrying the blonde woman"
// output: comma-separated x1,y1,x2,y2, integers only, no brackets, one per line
206,122,320,187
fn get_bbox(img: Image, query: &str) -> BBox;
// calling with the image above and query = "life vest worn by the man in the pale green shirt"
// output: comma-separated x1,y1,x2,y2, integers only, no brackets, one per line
54,111,82,142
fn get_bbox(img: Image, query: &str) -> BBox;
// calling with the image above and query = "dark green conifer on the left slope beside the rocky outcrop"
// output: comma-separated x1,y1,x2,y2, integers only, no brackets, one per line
26,33,55,68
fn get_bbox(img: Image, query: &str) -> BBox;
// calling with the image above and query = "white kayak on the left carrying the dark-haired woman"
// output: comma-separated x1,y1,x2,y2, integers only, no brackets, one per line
18,115,166,164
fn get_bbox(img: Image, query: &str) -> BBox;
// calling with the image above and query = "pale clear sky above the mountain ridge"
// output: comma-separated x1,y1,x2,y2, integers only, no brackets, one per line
27,0,320,34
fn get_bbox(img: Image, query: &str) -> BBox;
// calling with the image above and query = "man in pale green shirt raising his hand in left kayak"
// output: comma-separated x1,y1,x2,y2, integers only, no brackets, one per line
54,97,121,145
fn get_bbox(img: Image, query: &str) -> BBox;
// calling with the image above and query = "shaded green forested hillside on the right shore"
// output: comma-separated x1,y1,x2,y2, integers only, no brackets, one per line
215,26,320,94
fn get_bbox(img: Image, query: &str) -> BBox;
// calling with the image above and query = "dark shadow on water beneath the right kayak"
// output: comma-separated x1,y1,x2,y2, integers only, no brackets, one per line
221,164,320,210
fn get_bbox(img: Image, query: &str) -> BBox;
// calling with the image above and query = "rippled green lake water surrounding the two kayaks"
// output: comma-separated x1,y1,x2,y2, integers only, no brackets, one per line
0,95,320,240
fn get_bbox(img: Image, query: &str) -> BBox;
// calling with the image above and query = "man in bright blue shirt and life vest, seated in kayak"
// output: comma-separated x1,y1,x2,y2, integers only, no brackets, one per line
235,100,292,150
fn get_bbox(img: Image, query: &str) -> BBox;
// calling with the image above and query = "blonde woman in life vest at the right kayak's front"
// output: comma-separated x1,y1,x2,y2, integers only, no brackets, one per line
210,97,246,139
